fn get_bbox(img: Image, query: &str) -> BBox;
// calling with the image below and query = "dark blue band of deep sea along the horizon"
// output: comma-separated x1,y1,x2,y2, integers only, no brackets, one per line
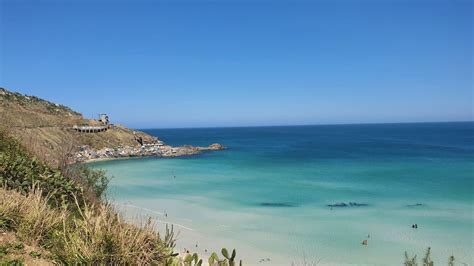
143,122,474,160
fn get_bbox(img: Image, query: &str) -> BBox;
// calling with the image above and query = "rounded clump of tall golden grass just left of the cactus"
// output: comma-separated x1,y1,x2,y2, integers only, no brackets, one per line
56,197,172,265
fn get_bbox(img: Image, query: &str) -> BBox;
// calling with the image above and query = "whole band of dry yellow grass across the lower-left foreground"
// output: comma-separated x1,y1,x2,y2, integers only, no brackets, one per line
0,188,172,265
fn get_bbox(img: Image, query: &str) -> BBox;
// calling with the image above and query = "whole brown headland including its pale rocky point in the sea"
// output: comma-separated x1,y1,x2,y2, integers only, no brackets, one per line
0,88,223,166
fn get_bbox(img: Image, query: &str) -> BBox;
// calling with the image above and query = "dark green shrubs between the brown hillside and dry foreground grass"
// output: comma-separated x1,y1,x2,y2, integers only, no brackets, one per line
0,131,108,206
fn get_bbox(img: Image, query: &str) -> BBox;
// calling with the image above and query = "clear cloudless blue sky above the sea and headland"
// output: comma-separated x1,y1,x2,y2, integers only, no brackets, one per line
0,0,474,128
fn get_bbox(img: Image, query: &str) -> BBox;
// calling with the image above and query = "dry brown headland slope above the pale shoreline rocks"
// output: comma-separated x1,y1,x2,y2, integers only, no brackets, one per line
0,88,157,166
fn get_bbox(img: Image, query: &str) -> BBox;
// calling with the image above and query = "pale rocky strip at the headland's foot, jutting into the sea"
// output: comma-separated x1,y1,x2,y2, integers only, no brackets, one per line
73,141,225,162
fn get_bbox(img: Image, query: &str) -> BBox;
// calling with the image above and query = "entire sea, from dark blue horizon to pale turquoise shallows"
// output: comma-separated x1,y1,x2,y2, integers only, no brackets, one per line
91,123,474,265
